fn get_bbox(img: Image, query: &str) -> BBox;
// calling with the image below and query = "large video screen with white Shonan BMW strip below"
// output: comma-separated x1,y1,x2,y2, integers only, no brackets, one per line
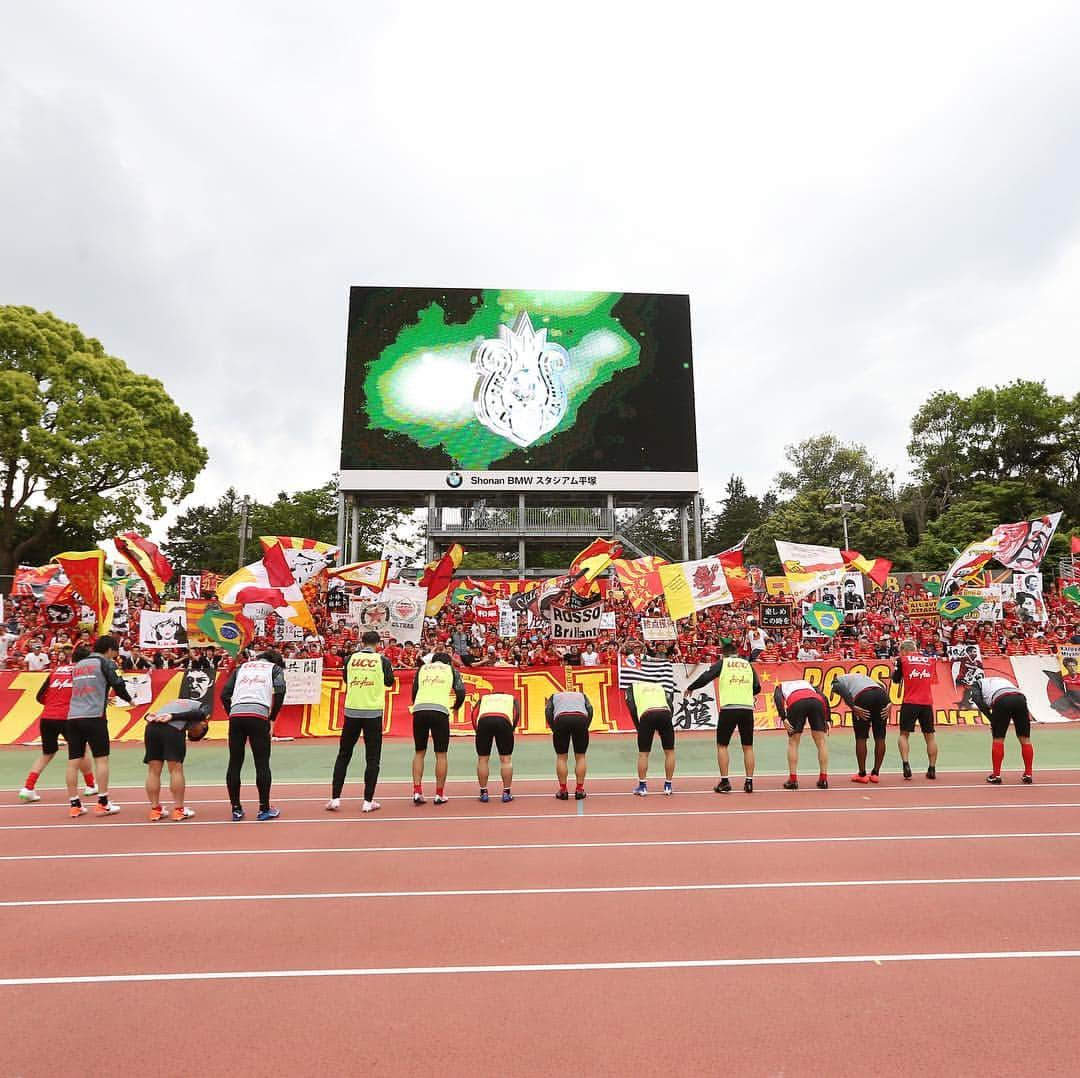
341,287,698,491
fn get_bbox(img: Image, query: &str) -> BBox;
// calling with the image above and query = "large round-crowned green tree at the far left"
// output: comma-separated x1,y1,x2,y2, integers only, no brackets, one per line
0,307,206,572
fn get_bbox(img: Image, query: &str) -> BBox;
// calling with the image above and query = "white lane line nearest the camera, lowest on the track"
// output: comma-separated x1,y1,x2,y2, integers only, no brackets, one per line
0,951,1080,988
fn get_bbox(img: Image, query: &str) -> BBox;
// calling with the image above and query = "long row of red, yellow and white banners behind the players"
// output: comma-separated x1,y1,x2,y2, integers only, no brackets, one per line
0,655,1080,744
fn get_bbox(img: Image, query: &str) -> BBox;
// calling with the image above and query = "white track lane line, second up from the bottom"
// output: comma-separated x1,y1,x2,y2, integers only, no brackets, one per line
0,876,1080,909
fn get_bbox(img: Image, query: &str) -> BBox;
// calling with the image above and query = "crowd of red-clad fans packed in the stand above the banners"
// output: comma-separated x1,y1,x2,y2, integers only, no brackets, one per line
0,574,1080,673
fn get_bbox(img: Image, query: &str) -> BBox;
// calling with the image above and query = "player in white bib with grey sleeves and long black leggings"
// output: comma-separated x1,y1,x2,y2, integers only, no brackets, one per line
221,650,285,820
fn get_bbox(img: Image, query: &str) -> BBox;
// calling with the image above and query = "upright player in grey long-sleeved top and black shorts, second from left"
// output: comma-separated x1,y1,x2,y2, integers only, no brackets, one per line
65,635,132,819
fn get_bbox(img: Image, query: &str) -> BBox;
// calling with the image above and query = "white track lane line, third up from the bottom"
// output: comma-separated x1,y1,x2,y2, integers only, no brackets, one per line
0,831,1080,862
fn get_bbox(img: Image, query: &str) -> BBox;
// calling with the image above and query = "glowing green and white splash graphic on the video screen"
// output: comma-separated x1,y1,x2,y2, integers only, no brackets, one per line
364,292,640,470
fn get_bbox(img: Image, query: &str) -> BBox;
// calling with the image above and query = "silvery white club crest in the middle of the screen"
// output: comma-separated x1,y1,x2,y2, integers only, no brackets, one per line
472,311,570,446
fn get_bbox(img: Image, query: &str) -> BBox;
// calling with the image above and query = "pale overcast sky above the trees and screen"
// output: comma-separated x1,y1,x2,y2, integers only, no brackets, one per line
6,0,1080,530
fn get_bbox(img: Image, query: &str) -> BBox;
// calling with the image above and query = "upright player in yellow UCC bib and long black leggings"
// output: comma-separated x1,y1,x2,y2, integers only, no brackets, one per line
326,629,394,812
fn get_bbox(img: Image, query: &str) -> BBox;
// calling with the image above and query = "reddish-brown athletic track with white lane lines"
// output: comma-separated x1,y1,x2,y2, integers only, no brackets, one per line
0,771,1080,1078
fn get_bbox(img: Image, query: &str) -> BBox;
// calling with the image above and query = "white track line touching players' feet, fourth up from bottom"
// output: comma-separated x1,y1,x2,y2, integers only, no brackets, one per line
0,795,1080,833
